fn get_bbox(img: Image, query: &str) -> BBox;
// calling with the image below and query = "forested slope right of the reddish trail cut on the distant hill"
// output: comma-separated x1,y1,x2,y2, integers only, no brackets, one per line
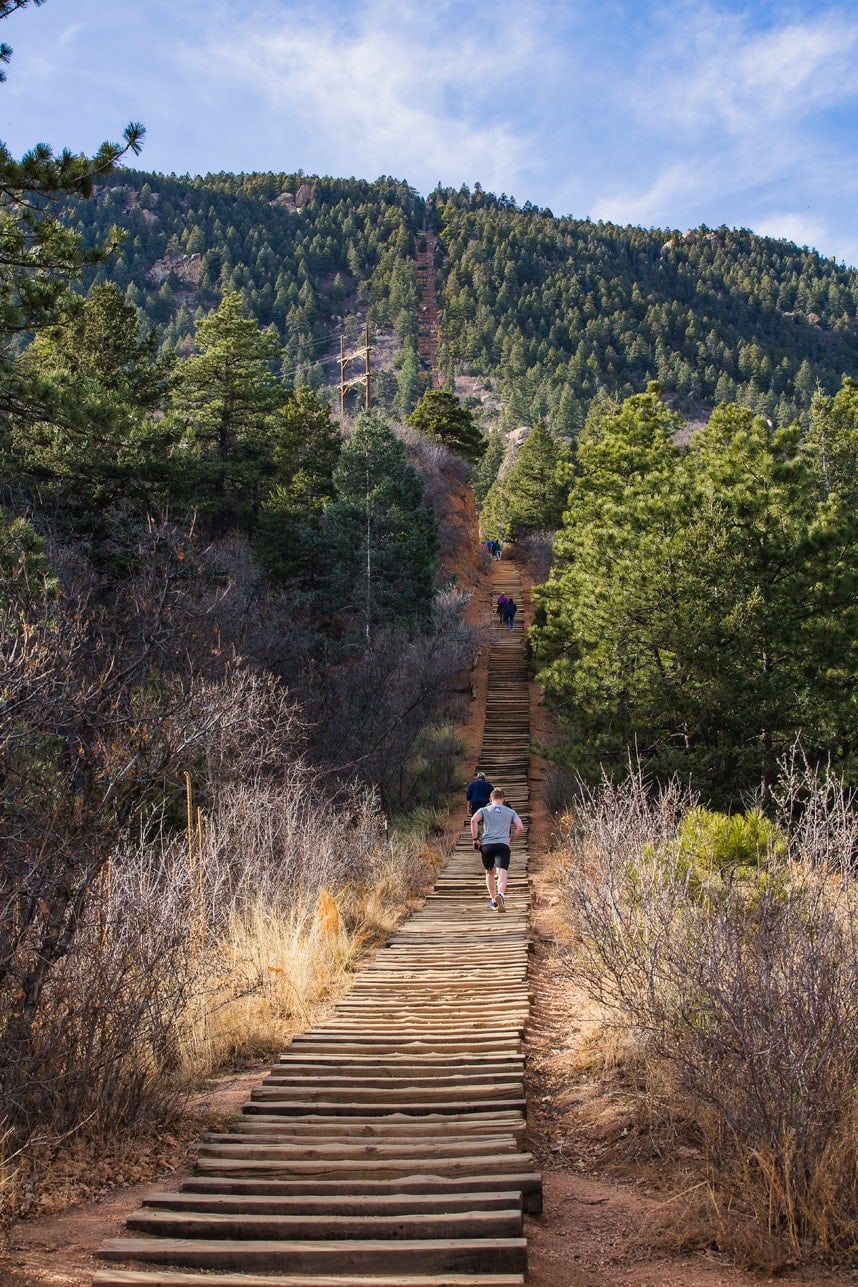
431,187,858,436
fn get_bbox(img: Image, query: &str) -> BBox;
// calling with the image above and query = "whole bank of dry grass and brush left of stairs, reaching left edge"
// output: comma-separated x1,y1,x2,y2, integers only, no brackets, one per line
0,761,450,1233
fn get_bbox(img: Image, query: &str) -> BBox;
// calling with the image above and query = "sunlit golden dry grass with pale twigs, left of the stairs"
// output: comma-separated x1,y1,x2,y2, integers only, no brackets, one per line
112,766,439,1084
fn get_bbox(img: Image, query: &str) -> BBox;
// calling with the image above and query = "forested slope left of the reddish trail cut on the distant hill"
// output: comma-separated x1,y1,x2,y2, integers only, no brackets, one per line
69,170,423,373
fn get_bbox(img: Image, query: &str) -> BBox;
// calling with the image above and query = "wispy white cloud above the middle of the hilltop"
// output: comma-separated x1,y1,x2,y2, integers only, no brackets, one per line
176,0,543,189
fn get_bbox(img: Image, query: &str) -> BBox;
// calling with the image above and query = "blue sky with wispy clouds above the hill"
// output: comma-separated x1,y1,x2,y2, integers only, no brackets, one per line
0,0,858,266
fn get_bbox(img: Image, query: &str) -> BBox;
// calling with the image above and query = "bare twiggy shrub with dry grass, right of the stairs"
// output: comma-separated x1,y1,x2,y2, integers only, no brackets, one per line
566,775,858,1266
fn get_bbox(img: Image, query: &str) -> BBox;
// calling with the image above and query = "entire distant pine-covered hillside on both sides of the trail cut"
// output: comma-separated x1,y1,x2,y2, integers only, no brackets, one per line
69,171,858,435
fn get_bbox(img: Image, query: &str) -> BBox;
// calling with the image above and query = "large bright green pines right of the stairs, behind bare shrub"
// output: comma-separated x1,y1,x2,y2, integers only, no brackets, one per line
534,380,858,802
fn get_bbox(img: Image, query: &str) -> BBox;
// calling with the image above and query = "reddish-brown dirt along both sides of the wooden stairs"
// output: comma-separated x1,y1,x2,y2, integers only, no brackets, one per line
0,527,855,1287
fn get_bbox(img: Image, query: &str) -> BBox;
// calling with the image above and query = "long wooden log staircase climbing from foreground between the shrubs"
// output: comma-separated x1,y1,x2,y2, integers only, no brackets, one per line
94,562,542,1287
